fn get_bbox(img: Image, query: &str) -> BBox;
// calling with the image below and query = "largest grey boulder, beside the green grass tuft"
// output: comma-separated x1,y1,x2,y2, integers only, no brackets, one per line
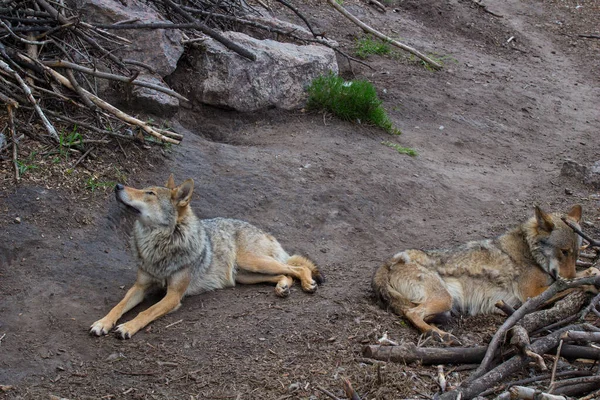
171,32,338,112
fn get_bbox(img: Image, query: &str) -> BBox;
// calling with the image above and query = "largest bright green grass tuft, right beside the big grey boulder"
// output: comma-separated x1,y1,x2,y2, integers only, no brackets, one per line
307,72,401,135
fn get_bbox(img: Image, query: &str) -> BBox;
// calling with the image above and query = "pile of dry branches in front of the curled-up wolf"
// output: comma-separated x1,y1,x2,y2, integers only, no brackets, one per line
364,220,600,400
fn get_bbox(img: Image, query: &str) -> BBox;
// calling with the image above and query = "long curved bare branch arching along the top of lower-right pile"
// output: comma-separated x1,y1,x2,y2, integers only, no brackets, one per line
468,276,600,381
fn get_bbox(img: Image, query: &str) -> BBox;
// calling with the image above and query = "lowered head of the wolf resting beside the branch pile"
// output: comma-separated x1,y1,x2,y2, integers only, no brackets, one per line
525,205,581,279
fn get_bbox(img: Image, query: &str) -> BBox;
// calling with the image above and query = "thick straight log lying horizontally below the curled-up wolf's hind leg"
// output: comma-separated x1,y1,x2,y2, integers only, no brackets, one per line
363,343,486,365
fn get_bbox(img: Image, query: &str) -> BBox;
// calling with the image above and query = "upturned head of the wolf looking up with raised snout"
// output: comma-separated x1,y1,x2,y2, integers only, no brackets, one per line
115,175,194,227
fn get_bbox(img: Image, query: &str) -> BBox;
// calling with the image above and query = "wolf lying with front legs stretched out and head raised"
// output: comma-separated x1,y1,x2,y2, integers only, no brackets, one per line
90,175,323,339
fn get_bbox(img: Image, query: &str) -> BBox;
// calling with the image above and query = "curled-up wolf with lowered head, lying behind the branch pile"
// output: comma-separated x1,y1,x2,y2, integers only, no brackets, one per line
372,205,581,339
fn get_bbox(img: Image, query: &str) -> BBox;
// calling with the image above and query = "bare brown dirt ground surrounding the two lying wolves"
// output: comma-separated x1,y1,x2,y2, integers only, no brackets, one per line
0,0,600,400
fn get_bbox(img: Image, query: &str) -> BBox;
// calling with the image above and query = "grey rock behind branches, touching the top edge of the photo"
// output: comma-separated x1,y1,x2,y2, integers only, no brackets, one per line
72,0,184,78
